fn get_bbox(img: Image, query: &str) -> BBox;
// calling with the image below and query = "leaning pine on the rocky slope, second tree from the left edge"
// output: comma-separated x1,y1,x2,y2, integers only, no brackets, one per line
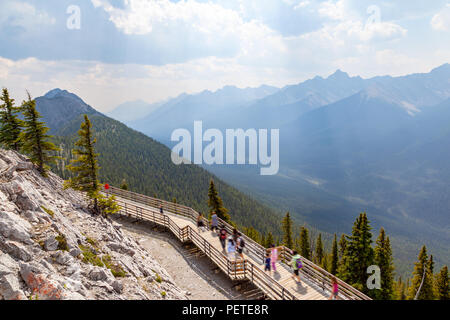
19,93,59,176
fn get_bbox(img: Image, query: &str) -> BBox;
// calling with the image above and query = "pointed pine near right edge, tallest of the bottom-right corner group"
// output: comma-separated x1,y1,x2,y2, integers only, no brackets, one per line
408,246,434,300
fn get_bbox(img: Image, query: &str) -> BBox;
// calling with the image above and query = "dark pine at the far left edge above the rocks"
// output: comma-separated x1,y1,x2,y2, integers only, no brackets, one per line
0,88,23,151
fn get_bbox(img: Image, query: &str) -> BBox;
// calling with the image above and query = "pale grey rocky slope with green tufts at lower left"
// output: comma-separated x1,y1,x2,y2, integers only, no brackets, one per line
0,149,187,300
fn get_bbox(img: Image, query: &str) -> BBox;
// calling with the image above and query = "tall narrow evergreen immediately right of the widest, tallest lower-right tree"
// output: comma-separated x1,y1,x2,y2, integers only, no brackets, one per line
374,228,394,300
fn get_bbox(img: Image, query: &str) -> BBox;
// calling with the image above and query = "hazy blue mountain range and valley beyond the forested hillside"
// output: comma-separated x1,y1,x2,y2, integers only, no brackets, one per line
109,64,450,276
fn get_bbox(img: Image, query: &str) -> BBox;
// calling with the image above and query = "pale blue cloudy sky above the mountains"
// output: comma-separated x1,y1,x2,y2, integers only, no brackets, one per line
0,0,450,112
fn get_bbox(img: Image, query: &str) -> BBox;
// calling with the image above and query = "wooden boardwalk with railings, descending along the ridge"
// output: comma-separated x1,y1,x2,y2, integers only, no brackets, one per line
108,187,370,300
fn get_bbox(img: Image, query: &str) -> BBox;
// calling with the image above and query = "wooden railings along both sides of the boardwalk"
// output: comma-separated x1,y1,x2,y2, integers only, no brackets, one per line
107,187,371,300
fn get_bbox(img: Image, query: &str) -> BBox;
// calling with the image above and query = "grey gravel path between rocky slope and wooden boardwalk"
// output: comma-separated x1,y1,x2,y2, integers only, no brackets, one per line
115,217,259,300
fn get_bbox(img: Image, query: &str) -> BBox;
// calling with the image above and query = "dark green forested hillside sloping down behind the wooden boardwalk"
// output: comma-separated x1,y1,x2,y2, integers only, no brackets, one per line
54,115,281,234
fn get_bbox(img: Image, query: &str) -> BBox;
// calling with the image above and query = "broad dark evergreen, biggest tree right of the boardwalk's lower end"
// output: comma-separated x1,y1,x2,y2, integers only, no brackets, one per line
338,212,374,294
